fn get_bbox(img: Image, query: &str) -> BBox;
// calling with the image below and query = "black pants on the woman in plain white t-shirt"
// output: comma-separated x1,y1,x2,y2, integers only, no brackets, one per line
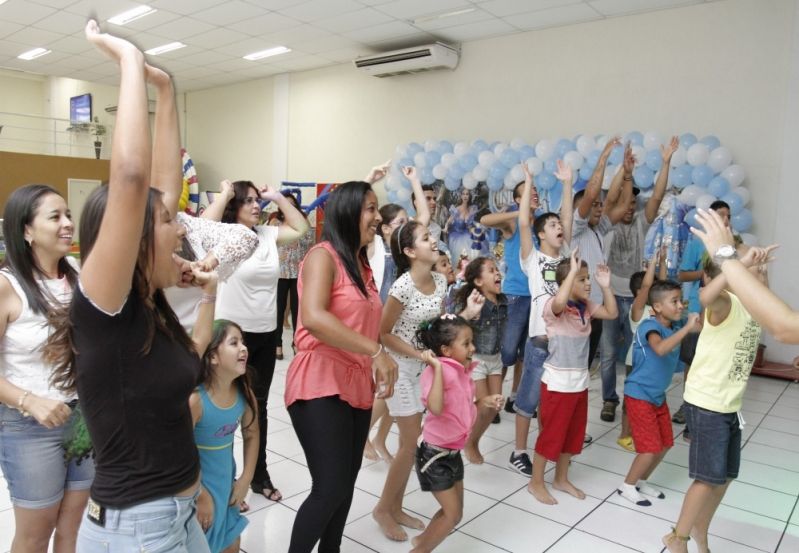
244,326,283,482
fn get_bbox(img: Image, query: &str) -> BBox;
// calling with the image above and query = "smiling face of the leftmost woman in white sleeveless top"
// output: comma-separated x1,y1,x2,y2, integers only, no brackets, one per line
25,194,75,258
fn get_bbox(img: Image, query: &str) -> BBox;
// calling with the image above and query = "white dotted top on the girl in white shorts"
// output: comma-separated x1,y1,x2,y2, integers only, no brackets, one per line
388,271,447,361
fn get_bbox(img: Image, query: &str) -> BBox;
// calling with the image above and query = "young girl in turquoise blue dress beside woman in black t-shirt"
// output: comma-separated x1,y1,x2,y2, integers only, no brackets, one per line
189,320,258,553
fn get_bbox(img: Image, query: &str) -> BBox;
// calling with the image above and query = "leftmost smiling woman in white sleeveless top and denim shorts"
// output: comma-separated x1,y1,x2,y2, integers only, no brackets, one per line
0,184,94,553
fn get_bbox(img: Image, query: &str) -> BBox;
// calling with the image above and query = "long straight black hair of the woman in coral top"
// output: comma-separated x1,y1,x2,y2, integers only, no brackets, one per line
322,181,372,297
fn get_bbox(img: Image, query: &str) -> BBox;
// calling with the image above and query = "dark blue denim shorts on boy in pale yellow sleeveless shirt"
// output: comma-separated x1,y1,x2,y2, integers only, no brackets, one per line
685,402,741,485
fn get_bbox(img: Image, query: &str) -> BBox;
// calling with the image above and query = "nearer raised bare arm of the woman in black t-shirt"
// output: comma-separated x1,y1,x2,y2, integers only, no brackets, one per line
80,20,151,313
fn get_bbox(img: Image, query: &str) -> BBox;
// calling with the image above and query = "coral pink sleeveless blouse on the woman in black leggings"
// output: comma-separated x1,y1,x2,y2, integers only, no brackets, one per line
285,242,383,409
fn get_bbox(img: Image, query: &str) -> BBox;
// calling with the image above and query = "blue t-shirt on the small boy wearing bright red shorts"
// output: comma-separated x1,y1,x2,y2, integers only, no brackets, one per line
624,317,680,406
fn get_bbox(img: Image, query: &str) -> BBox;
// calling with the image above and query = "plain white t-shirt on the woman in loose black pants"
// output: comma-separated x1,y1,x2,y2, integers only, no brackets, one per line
216,225,280,332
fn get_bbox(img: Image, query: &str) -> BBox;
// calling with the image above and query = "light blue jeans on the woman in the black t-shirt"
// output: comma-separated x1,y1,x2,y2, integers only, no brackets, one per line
76,495,210,553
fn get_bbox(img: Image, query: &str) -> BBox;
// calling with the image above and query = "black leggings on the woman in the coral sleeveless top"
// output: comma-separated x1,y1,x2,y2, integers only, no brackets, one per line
288,396,372,553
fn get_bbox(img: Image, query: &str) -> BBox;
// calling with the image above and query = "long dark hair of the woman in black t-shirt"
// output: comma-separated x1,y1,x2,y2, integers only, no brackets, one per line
44,186,194,391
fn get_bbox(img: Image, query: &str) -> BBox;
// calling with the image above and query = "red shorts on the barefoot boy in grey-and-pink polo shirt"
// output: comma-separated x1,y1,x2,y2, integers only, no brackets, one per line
535,382,588,462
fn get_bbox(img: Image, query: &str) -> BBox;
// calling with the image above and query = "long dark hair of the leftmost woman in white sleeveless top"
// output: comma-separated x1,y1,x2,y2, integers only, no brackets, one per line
0,184,78,315
